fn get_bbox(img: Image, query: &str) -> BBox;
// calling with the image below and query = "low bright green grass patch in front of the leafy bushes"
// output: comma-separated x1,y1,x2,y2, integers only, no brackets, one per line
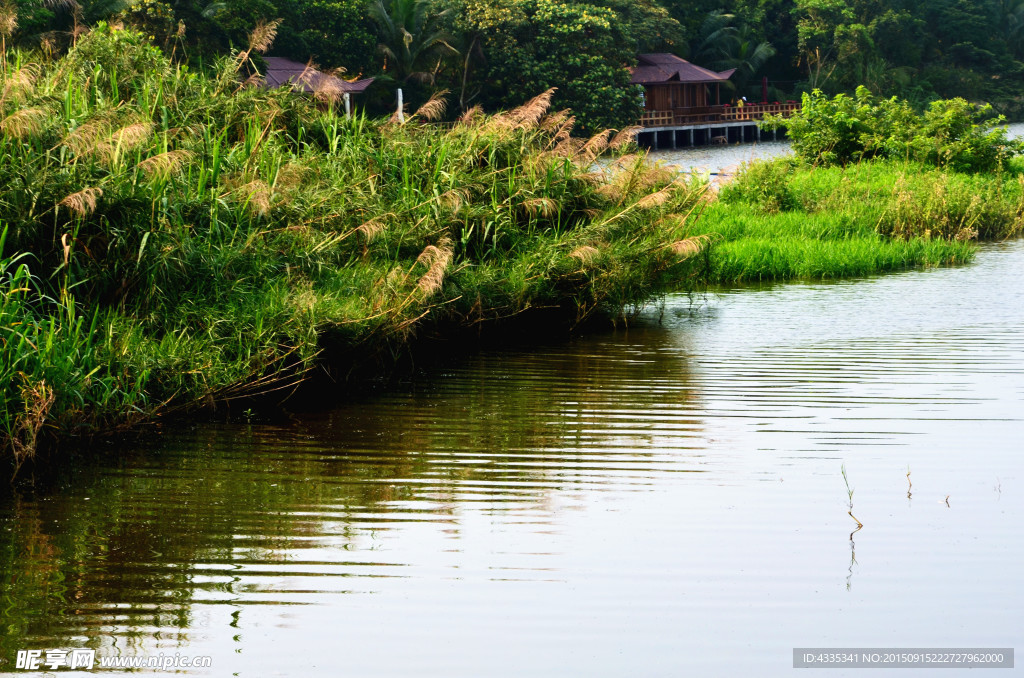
704,157,1024,283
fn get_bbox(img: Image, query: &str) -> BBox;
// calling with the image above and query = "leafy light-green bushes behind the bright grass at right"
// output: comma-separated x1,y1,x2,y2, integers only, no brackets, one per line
765,87,1024,172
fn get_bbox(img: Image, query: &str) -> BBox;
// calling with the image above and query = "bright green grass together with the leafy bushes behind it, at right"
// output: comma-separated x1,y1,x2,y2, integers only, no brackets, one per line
690,87,1024,283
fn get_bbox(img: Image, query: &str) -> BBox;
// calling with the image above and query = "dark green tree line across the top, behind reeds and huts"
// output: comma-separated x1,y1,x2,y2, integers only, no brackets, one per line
8,0,1024,124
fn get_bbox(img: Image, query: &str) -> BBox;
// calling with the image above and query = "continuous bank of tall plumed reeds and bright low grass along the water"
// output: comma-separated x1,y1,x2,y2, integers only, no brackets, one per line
0,29,1024,471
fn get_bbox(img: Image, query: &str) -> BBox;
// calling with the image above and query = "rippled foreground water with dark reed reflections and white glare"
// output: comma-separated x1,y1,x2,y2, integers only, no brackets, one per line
0,243,1024,676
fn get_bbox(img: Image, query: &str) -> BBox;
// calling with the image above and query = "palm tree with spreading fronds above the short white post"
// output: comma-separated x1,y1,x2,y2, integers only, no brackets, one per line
370,0,459,83
